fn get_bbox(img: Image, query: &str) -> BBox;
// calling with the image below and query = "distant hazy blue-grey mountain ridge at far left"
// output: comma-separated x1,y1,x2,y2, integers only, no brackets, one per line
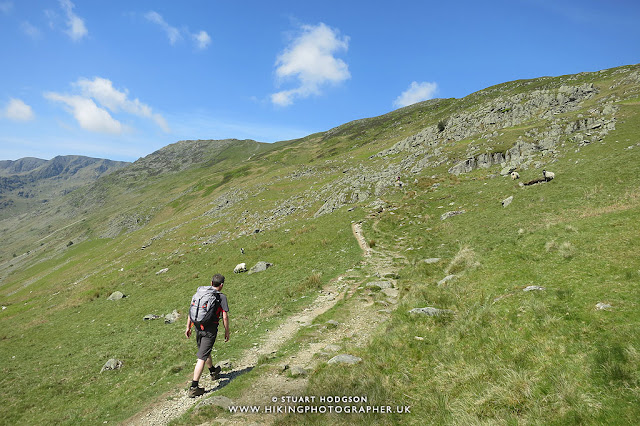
0,155,130,218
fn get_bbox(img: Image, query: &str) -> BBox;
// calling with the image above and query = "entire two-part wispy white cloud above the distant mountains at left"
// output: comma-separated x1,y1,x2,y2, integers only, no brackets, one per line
44,77,170,134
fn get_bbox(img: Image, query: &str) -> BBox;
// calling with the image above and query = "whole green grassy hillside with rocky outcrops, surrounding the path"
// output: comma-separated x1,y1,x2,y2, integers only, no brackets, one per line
0,66,640,424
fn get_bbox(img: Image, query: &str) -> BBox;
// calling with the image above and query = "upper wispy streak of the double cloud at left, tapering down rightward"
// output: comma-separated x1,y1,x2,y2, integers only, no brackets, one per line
74,77,171,133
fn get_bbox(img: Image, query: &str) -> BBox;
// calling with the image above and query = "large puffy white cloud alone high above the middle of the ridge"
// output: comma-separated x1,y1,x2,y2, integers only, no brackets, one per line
271,23,351,106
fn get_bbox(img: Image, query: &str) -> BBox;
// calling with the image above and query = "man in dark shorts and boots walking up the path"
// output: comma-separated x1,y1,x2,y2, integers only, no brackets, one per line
184,274,229,398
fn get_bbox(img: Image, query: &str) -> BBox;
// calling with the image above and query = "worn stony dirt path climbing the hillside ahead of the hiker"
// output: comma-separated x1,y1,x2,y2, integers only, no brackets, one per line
125,223,397,425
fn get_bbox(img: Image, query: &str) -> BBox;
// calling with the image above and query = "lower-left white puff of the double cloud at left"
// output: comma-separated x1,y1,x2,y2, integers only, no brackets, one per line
44,92,123,134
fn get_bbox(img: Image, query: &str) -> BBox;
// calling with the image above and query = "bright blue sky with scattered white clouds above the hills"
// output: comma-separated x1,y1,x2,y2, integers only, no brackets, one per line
0,0,640,161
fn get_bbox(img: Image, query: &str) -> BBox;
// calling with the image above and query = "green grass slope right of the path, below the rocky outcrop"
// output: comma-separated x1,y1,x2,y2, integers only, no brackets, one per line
282,99,640,425
